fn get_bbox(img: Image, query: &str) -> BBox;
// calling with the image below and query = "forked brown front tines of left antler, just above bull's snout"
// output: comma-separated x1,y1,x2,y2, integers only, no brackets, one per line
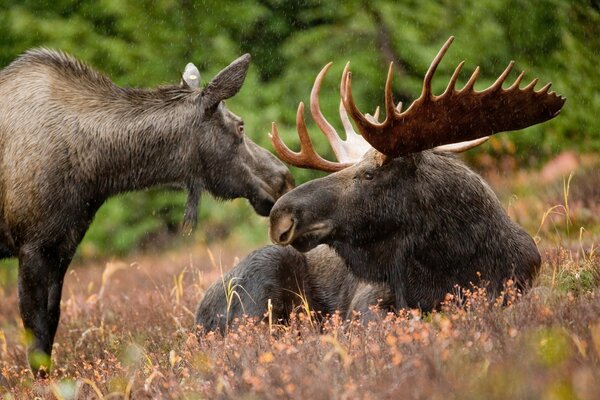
269,102,351,172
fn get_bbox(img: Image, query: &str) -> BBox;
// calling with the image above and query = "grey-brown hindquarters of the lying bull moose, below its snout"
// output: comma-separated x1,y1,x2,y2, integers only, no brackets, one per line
196,246,395,333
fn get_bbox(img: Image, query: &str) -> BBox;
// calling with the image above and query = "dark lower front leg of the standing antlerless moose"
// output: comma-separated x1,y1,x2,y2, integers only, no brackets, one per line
19,244,54,377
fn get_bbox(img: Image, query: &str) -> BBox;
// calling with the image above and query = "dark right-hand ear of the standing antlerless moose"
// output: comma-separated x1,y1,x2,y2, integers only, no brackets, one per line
202,54,250,109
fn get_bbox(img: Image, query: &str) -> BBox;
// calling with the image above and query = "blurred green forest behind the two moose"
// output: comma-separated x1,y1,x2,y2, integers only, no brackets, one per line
0,0,600,258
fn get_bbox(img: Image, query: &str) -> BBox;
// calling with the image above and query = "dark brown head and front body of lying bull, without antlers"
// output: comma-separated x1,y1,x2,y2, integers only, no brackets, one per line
270,150,540,311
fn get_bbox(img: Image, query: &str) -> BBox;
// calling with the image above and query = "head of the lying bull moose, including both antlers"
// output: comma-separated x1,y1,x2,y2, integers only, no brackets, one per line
270,37,565,256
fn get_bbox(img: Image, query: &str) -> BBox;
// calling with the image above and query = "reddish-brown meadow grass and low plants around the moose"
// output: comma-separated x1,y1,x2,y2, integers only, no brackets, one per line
0,166,600,399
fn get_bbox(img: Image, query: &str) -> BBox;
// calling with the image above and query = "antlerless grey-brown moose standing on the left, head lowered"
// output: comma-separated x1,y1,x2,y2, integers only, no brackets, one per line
0,49,293,375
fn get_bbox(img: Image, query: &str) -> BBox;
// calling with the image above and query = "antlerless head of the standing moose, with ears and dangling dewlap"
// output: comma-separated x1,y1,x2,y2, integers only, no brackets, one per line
176,54,294,230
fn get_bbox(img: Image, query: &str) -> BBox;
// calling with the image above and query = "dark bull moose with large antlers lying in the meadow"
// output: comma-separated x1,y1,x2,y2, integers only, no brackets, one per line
197,37,565,329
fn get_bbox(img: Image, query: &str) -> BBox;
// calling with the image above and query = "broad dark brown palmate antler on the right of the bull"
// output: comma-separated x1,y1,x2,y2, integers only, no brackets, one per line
342,37,566,157
